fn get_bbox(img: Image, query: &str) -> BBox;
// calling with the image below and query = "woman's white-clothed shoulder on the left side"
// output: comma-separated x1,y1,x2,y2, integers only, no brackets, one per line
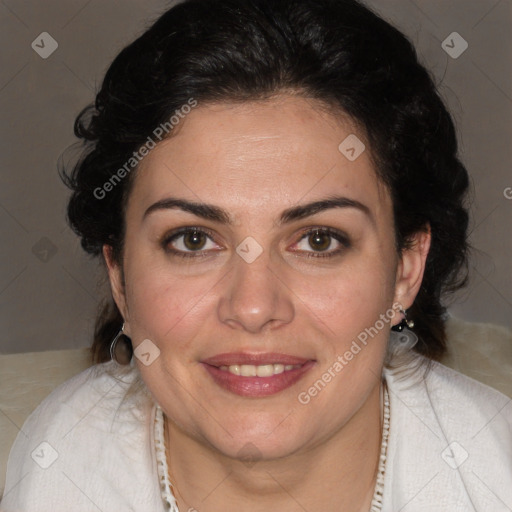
0,362,164,512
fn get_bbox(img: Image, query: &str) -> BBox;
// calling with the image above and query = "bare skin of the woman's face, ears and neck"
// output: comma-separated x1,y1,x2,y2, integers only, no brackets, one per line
104,94,430,512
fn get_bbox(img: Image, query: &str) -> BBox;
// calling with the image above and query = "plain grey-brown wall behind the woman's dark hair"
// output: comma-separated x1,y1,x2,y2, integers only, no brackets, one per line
0,0,512,353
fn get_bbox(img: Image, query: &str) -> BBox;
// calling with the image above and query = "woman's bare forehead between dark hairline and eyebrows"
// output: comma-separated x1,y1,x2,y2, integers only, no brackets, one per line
130,96,389,221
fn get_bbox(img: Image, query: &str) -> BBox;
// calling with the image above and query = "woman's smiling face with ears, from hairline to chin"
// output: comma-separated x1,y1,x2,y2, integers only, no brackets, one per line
106,96,428,458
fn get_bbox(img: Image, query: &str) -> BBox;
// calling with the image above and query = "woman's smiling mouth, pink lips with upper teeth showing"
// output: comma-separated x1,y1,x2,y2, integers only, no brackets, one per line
201,353,316,398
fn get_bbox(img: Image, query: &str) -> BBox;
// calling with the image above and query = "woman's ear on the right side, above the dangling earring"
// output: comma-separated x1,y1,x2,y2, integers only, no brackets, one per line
394,224,431,316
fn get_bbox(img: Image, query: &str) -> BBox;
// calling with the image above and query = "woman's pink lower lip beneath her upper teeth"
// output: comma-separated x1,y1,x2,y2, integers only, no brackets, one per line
202,361,315,397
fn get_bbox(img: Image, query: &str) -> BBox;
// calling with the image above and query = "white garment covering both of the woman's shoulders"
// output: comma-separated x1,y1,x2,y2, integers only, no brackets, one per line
0,358,512,512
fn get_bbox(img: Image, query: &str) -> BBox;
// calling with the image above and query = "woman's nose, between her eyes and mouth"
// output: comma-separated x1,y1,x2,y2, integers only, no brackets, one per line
218,247,294,333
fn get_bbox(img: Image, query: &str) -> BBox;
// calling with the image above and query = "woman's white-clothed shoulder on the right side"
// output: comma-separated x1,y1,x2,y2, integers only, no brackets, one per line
384,357,512,512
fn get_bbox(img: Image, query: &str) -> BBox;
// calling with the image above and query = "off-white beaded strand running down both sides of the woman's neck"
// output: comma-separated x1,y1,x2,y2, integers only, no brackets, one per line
155,381,390,512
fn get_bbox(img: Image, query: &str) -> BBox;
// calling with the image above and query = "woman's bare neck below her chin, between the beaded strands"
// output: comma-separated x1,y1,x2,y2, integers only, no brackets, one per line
165,385,382,512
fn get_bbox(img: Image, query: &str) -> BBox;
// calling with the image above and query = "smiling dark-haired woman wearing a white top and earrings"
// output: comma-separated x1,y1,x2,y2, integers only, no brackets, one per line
2,0,512,512
